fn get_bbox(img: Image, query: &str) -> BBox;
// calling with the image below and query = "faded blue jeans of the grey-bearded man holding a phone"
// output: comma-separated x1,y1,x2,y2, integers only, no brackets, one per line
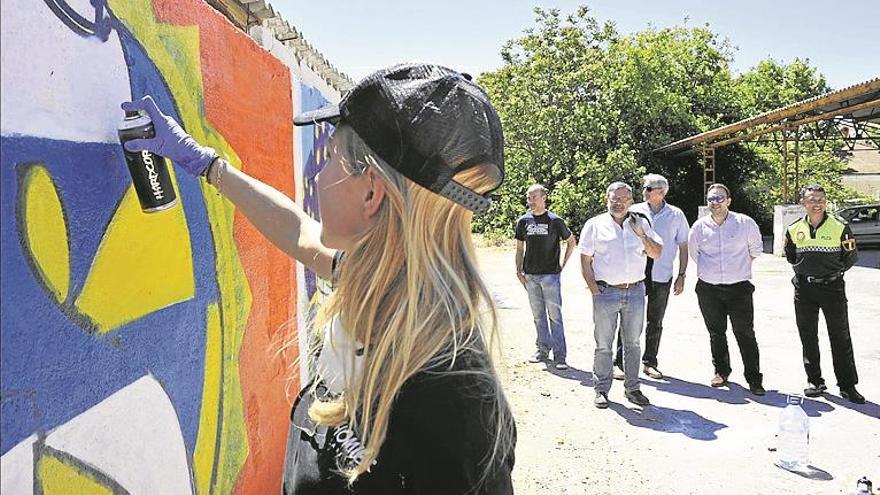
593,283,645,394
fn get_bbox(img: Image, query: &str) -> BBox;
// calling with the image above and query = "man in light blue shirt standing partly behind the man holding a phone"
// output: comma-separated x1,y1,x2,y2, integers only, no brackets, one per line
614,174,690,380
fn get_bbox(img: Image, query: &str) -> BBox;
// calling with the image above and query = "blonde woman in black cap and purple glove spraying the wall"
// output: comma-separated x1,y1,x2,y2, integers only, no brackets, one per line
123,64,515,494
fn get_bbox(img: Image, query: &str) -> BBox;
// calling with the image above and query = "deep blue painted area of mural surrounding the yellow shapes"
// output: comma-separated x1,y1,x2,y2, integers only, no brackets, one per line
0,20,218,455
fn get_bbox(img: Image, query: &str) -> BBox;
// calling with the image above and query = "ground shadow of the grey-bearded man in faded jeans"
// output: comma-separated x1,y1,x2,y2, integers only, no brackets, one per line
608,402,727,441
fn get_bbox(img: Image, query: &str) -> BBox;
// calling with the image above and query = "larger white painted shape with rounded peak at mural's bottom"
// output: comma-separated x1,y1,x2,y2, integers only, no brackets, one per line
46,375,193,495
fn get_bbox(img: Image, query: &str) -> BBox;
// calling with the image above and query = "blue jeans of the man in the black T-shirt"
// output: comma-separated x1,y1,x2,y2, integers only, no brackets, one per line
526,273,566,363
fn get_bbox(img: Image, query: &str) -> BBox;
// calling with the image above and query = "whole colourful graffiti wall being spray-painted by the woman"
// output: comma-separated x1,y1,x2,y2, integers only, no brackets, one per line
0,0,338,494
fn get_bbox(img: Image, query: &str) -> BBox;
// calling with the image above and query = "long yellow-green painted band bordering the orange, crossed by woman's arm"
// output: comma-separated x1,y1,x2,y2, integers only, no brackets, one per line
109,0,252,493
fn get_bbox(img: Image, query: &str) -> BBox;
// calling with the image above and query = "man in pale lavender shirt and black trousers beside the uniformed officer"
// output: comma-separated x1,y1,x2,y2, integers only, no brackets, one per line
688,184,766,395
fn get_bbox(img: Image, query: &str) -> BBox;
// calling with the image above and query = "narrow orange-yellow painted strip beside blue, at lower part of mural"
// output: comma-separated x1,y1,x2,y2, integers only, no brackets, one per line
193,304,223,495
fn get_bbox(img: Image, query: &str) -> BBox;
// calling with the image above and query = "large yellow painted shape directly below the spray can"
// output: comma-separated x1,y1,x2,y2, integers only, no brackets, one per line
76,187,195,334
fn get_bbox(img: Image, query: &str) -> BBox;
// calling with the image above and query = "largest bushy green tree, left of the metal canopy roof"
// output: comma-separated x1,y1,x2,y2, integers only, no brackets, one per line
476,7,739,235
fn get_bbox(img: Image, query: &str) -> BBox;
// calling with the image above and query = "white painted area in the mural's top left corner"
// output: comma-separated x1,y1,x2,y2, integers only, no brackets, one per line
0,0,131,143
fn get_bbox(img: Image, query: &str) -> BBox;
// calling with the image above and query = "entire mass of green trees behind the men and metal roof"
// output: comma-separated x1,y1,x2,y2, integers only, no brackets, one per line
475,7,851,237
